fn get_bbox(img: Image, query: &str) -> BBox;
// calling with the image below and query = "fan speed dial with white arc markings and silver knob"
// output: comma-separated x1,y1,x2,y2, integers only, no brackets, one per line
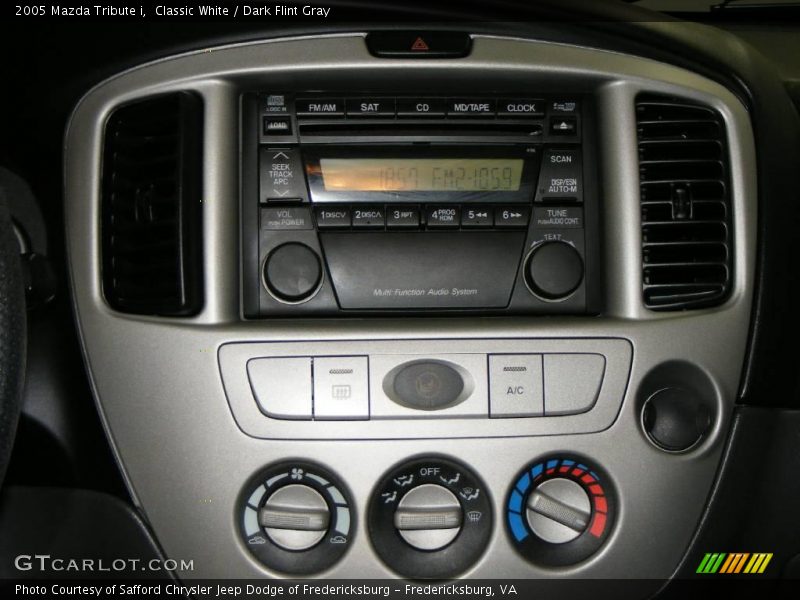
240,462,353,575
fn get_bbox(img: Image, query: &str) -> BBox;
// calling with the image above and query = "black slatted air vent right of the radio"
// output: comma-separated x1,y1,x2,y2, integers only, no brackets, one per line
636,96,732,310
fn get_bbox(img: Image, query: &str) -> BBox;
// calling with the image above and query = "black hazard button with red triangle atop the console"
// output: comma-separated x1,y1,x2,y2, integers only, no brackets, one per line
367,31,472,58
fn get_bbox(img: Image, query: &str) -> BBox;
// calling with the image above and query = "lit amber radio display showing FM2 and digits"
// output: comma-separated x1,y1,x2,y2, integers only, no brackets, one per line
319,158,524,192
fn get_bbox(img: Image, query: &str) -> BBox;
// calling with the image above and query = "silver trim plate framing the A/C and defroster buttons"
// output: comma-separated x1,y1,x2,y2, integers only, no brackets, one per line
219,339,631,440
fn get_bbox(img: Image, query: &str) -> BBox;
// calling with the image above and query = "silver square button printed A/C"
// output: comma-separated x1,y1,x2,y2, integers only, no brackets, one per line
489,354,544,417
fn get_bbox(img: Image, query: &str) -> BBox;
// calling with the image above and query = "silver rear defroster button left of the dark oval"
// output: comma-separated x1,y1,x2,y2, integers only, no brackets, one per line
314,356,369,420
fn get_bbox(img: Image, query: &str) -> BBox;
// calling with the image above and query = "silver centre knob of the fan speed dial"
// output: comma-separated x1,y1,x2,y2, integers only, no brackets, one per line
258,484,330,551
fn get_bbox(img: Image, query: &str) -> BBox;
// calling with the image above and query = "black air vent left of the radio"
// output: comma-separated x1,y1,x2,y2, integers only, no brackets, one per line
102,92,203,316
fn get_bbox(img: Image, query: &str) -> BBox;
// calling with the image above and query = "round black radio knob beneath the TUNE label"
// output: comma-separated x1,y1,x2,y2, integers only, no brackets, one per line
525,242,583,300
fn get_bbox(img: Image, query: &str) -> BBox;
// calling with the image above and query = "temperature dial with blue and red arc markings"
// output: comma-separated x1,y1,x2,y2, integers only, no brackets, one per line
506,457,616,566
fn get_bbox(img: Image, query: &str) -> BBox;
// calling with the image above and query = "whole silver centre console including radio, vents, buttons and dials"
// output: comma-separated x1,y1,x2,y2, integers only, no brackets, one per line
65,33,756,585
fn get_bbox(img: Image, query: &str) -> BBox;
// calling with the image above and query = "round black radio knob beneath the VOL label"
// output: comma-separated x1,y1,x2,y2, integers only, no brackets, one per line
264,242,322,303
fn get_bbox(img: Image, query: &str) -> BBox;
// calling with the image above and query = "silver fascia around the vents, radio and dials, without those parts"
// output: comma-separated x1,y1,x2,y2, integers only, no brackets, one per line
65,33,756,579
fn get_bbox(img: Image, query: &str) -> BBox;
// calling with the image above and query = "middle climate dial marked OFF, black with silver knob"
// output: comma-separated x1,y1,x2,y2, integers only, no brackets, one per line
368,457,492,578
